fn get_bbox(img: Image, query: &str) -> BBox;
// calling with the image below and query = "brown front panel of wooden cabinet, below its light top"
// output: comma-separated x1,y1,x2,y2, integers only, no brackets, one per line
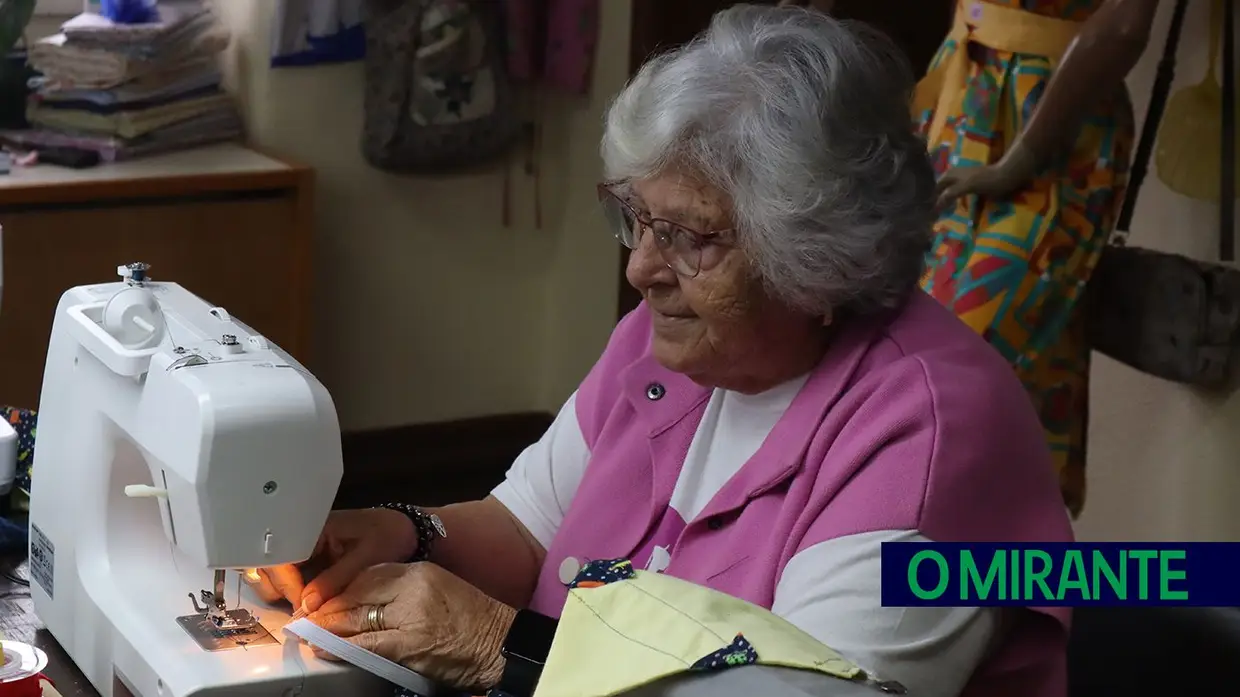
0,192,305,407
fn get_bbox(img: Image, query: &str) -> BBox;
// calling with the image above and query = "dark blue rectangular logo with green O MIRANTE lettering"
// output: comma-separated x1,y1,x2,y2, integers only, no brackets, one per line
882,542,1240,608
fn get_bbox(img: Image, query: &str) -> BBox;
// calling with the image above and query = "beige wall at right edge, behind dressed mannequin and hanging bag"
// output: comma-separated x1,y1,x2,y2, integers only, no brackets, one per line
1078,1,1240,541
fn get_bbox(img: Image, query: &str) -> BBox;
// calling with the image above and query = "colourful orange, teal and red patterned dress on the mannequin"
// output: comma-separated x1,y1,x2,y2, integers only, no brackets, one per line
918,0,1133,515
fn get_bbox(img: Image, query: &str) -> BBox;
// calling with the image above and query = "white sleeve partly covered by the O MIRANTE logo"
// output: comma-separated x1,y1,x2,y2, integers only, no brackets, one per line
771,531,1002,697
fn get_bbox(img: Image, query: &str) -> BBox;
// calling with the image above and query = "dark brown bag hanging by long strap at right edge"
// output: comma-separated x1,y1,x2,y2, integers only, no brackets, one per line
1085,0,1240,388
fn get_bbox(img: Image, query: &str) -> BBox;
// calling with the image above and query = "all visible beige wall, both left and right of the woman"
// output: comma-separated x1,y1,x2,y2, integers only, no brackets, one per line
36,0,1240,539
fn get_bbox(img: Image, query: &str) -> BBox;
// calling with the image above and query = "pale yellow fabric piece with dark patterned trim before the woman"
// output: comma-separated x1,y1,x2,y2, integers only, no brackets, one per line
534,570,864,697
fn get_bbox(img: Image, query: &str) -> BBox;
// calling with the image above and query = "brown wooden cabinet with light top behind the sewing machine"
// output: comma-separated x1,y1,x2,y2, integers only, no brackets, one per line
0,145,314,408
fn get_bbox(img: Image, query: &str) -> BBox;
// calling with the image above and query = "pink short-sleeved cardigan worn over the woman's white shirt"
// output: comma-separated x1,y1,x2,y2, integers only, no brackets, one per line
532,291,1073,697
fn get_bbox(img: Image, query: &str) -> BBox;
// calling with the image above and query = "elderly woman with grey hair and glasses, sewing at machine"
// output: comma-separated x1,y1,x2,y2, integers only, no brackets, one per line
260,5,1071,697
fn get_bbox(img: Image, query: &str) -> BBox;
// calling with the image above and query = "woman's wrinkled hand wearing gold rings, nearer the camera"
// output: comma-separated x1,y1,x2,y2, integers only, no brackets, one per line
310,562,517,695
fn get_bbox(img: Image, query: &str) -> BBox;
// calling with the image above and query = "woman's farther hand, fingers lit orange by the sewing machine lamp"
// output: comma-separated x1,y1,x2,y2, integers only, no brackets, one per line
243,508,418,613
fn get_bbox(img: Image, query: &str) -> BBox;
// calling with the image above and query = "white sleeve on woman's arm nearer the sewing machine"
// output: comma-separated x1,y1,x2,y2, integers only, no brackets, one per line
491,392,590,549
